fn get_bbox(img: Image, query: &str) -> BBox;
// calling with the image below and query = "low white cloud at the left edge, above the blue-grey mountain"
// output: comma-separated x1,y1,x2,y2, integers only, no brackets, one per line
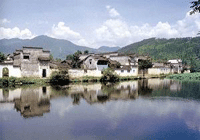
0,27,35,39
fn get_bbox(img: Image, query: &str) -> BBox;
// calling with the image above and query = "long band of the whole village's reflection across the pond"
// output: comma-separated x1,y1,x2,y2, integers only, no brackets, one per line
0,79,200,118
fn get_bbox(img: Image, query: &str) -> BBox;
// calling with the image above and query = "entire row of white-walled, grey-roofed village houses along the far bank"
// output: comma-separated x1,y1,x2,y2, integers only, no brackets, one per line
0,47,187,78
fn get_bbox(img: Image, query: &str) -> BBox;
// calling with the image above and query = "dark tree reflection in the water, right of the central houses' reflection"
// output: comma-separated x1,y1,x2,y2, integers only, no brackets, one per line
138,79,153,96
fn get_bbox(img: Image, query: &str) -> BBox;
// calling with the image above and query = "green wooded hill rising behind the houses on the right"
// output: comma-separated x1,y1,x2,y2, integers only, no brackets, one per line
118,37,200,62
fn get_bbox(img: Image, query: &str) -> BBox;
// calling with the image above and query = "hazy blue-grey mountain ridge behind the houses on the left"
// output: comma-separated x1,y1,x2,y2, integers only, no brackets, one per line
0,35,120,59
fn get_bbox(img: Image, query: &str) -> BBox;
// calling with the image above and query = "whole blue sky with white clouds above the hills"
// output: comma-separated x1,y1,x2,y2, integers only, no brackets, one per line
0,0,200,48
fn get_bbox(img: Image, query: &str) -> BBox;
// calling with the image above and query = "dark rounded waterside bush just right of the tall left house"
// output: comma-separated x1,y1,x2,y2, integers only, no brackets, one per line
50,71,69,85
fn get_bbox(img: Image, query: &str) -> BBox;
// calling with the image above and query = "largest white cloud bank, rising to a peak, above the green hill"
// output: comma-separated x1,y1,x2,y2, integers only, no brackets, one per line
94,6,200,46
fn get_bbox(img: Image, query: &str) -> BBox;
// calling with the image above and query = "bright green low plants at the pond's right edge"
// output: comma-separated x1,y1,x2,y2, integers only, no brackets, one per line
167,72,200,81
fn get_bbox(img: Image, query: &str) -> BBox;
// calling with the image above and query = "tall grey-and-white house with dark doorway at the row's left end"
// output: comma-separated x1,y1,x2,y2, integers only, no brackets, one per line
0,47,50,78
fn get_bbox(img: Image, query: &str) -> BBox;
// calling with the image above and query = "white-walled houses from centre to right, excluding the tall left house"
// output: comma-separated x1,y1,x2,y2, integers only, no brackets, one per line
68,52,186,78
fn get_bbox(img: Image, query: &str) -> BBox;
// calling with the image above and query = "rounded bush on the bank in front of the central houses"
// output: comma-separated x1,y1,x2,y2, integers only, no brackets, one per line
100,68,119,82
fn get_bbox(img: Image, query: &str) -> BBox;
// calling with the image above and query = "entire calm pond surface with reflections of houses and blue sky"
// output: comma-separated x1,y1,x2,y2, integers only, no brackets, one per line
0,79,200,140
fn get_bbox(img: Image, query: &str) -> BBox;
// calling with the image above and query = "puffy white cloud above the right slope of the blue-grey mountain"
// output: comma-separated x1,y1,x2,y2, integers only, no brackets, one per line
46,22,87,45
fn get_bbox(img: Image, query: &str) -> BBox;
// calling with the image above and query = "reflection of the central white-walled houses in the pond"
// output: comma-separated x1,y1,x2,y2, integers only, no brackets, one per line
68,81,138,104
